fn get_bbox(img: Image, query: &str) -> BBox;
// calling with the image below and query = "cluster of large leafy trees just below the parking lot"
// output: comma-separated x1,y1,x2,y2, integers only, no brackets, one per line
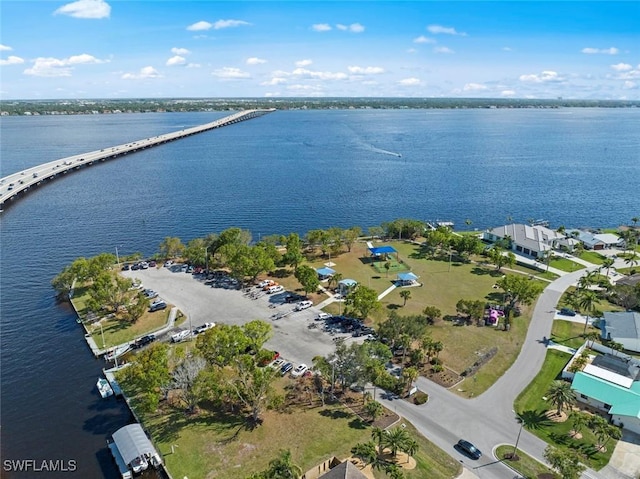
123,320,276,425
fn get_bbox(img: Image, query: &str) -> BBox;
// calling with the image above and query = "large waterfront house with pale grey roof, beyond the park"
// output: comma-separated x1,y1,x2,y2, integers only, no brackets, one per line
482,224,564,258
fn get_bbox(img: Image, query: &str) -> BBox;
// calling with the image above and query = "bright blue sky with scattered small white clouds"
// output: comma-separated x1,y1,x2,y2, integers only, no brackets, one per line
0,0,640,100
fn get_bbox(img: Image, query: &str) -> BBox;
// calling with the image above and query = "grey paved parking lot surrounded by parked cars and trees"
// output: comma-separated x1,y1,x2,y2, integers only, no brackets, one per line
122,267,362,366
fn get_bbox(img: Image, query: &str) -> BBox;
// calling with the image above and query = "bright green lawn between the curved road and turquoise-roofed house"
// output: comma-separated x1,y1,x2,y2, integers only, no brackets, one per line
515,349,616,470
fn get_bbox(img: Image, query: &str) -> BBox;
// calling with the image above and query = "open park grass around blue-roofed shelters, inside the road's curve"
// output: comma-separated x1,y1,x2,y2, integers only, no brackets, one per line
312,241,546,397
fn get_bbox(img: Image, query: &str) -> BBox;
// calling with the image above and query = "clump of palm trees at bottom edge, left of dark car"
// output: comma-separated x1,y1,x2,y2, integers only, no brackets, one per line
351,427,420,479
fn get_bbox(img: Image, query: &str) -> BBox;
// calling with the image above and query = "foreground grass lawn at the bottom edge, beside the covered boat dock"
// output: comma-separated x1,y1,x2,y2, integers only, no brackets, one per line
145,398,460,479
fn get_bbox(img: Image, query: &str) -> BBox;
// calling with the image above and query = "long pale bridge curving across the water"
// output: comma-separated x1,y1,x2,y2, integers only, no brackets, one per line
0,108,275,212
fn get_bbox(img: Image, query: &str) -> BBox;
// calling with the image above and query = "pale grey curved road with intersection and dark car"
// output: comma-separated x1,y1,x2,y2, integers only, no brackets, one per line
378,266,624,479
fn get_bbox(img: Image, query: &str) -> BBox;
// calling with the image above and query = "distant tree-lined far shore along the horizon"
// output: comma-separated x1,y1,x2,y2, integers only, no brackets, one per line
0,97,640,115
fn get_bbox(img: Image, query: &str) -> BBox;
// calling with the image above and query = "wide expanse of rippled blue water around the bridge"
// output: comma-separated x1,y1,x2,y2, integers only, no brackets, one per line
0,109,640,477
